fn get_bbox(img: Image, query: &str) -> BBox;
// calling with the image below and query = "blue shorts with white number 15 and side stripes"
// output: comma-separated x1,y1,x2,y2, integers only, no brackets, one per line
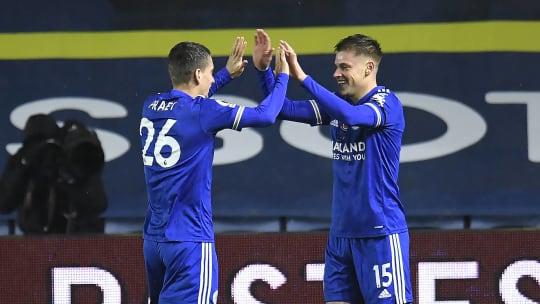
323,231,413,304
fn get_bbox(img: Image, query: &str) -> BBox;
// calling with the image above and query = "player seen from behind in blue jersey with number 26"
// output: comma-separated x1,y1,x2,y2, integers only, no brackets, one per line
140,37,289,304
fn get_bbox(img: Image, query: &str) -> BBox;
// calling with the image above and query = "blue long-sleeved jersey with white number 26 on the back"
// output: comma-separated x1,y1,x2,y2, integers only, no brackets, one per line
140,70,288,242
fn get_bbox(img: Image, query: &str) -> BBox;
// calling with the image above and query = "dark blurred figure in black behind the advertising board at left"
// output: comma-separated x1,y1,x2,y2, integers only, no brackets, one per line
0,114,108,235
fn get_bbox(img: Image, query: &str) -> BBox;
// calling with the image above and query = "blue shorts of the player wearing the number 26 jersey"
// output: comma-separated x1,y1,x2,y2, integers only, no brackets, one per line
143,240,218,304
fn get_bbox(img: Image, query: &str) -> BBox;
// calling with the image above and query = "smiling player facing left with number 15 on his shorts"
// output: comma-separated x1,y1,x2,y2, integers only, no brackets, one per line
253,29,413,304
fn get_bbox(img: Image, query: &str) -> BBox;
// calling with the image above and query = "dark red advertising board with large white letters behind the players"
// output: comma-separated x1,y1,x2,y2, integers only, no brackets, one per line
0,230,540,304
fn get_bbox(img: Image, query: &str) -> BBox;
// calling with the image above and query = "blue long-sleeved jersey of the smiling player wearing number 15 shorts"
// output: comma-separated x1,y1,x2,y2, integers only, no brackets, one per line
257,69,408,237
